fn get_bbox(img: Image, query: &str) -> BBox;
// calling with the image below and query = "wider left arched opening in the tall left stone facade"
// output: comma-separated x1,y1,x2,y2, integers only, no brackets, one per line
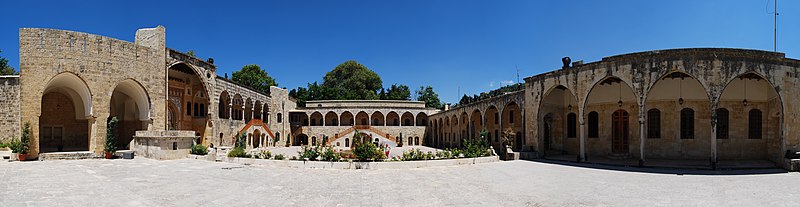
38,73,92,153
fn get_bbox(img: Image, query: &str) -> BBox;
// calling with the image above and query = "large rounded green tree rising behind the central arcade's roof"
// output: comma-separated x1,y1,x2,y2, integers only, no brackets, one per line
322,60,383,100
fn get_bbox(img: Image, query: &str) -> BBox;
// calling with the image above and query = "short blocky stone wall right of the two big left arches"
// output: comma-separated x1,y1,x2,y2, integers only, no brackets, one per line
133,131,198,160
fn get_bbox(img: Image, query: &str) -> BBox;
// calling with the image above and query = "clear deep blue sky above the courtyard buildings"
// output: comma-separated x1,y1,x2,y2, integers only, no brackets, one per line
0,0,800,102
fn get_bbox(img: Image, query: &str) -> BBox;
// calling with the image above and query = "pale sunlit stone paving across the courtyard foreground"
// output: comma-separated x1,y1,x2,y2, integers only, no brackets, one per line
0,158,800,206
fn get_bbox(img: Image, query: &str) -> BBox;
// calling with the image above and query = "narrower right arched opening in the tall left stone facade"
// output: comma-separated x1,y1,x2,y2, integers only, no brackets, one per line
109,79,150,149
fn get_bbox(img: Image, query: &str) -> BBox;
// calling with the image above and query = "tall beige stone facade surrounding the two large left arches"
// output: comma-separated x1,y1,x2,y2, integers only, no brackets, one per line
19,26,166,157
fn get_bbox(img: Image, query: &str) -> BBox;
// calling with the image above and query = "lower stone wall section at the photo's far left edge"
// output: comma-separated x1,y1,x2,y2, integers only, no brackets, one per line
0,76,22,142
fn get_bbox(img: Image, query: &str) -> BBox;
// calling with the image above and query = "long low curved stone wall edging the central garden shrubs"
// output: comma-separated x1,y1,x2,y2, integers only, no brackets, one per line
189,155,500,169
